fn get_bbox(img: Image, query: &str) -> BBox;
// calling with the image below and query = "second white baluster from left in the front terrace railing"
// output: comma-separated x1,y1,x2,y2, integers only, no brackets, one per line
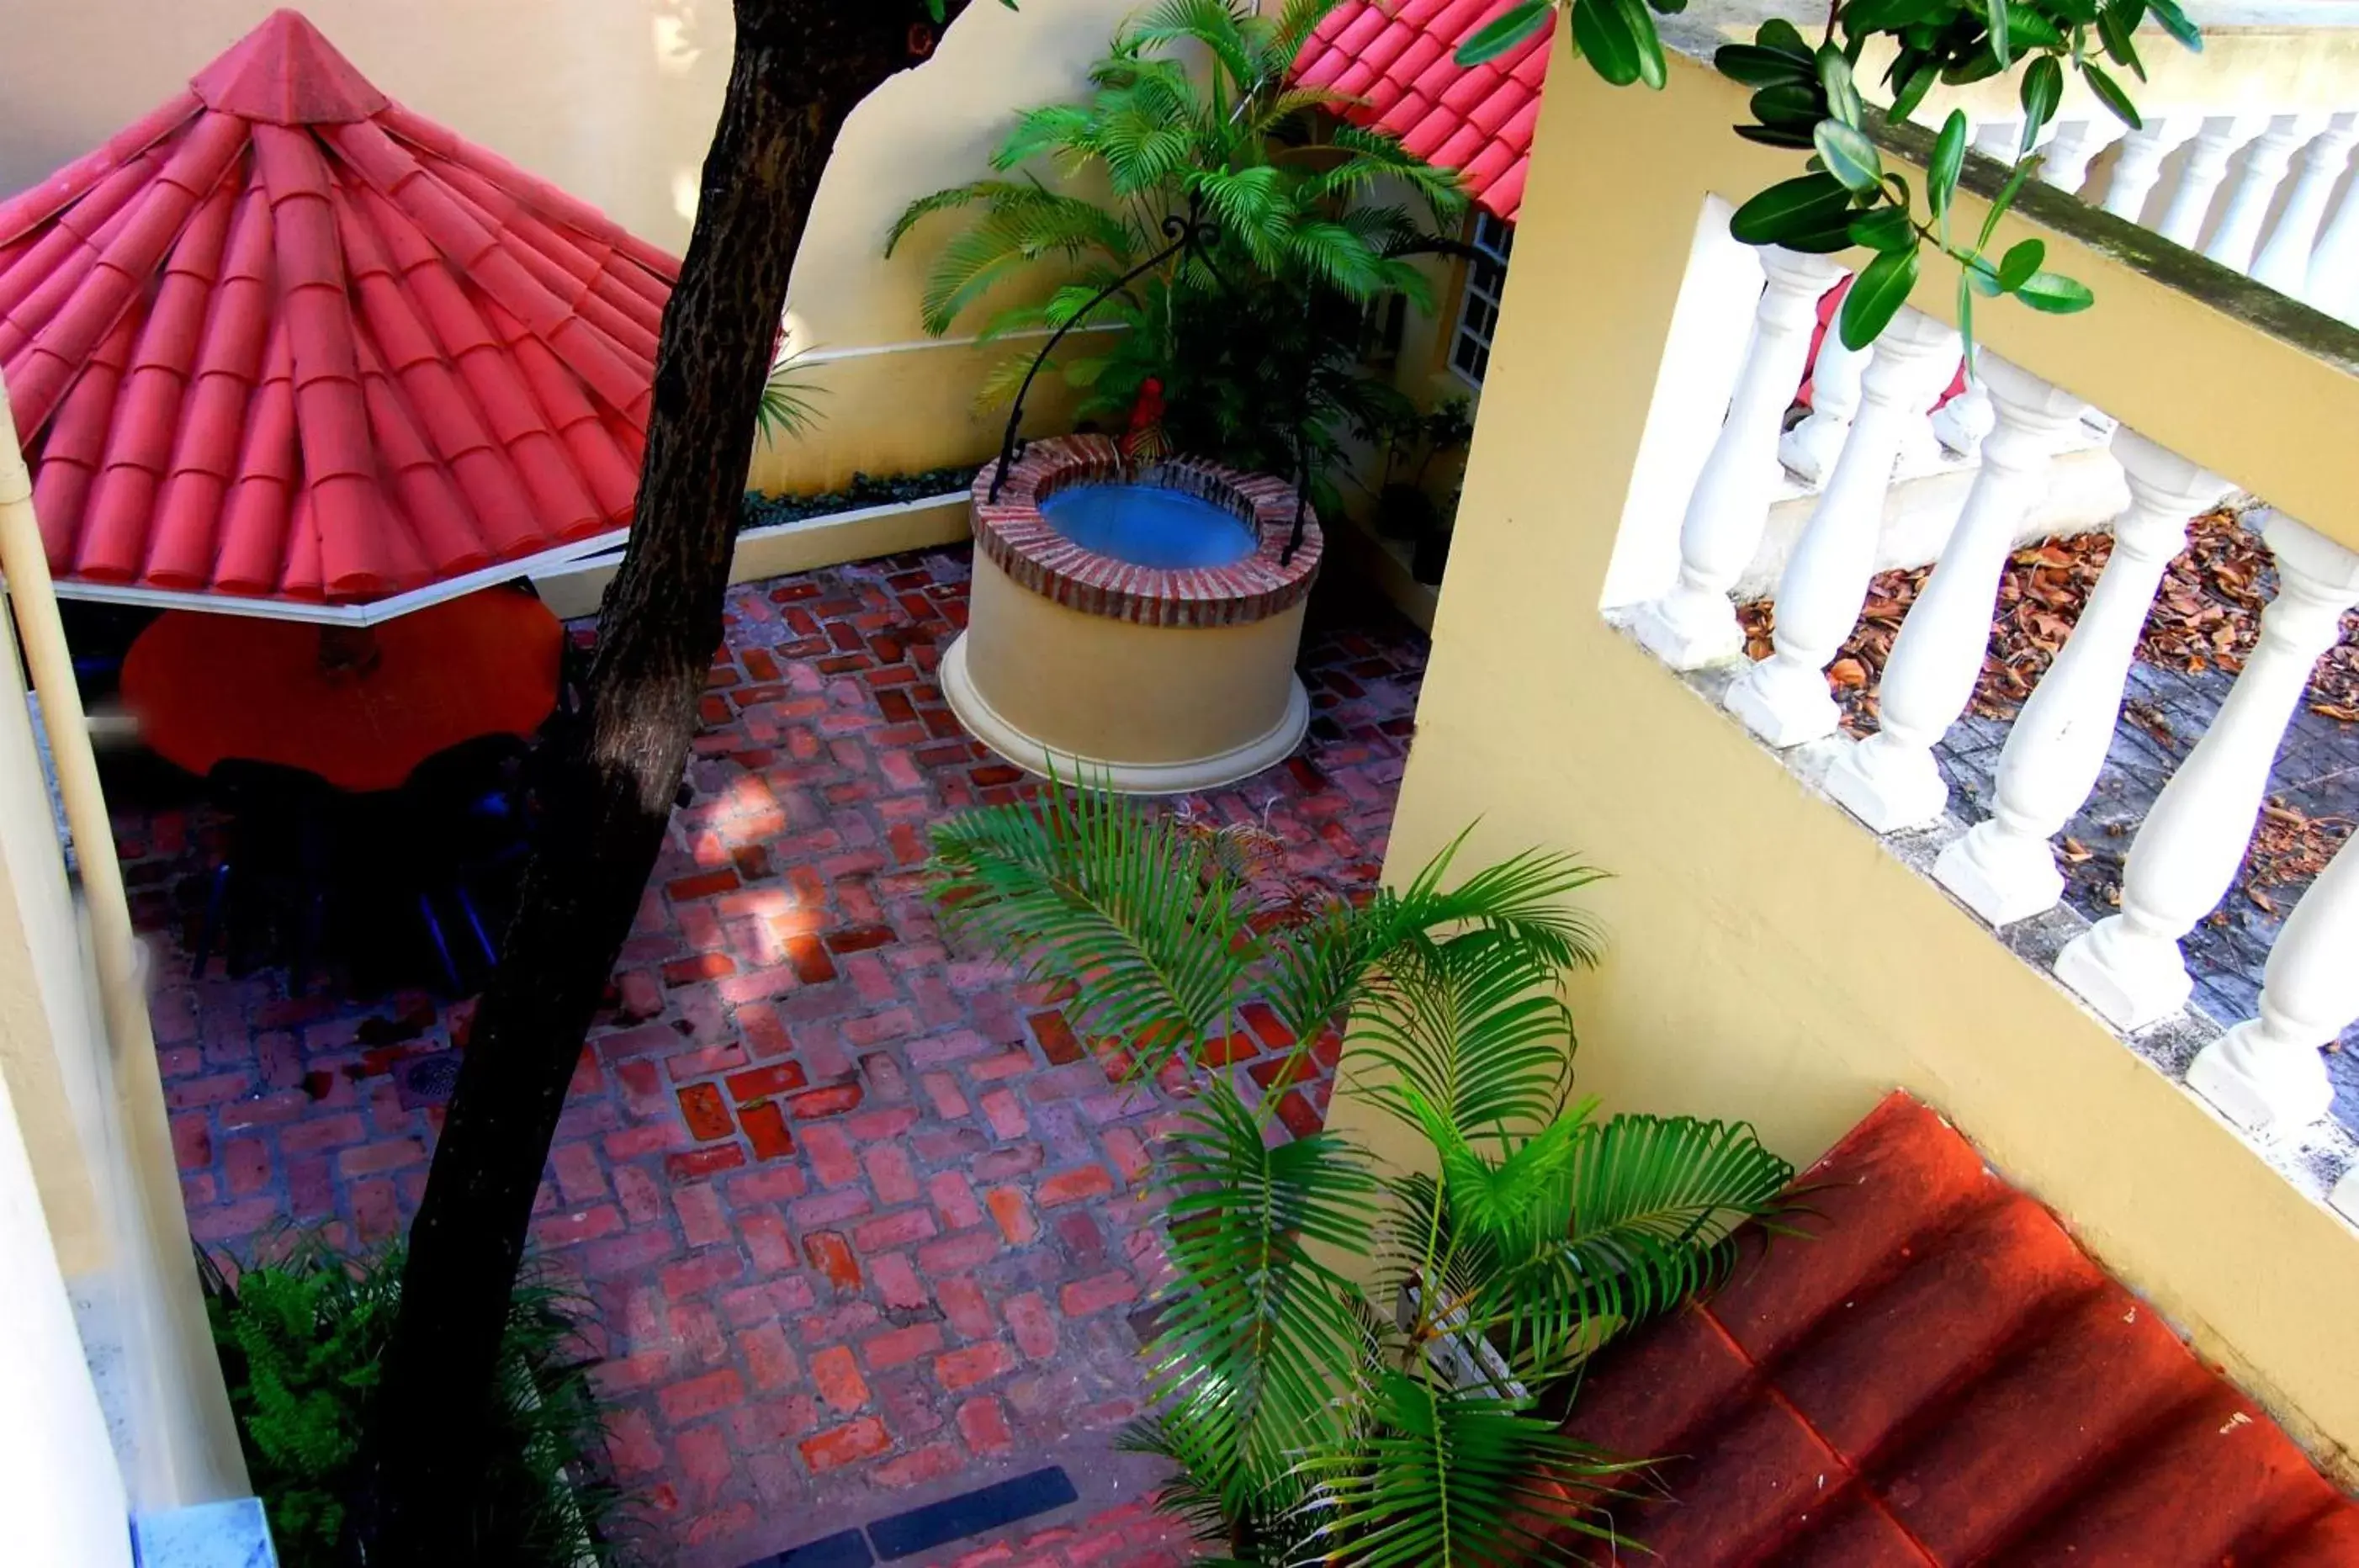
1727,309,1958,748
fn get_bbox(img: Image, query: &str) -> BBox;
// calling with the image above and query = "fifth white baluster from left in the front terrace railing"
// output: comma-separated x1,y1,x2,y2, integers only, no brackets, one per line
2057,514,2359,1030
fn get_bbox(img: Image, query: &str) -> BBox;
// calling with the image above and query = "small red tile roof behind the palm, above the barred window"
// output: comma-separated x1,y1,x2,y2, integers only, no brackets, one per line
1295,0,1555,221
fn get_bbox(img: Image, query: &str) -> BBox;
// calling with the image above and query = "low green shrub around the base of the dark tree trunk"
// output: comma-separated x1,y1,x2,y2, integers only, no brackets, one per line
200,1238,618,1568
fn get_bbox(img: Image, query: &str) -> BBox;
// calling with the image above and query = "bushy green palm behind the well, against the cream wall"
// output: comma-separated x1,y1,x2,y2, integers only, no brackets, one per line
885,0,1462,504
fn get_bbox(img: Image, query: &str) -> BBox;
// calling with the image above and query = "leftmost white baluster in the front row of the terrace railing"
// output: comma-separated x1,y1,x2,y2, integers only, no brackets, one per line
1630,246,1842,670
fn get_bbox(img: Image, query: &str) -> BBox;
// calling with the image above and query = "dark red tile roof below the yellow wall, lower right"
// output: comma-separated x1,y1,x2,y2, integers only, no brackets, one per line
1569,1094,2359,1568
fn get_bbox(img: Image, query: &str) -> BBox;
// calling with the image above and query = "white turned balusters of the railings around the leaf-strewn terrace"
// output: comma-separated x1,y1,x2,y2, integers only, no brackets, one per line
1630,140,2359,1155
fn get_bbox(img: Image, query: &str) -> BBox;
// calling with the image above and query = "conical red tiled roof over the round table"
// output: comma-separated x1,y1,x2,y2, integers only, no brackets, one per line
0,12,680,604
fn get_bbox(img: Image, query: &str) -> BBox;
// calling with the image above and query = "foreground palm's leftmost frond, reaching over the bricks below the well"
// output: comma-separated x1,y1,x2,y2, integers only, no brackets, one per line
932,785,1250,1066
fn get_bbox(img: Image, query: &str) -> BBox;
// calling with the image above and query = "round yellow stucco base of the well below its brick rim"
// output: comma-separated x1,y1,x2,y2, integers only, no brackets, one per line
941,552,1312,795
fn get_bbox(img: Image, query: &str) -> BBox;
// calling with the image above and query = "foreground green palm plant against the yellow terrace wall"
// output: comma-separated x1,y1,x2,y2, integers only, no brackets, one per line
934,787,1793,1568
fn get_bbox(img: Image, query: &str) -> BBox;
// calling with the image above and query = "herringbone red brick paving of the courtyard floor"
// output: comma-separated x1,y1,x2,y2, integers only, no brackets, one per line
118,552,1425,1565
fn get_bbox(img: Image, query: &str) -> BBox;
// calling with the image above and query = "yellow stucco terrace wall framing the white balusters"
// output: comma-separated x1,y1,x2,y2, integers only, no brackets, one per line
1335,36,2359,1465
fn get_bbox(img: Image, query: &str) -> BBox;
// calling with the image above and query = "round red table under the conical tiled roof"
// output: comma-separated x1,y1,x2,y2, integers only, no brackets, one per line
123,590,566,792
